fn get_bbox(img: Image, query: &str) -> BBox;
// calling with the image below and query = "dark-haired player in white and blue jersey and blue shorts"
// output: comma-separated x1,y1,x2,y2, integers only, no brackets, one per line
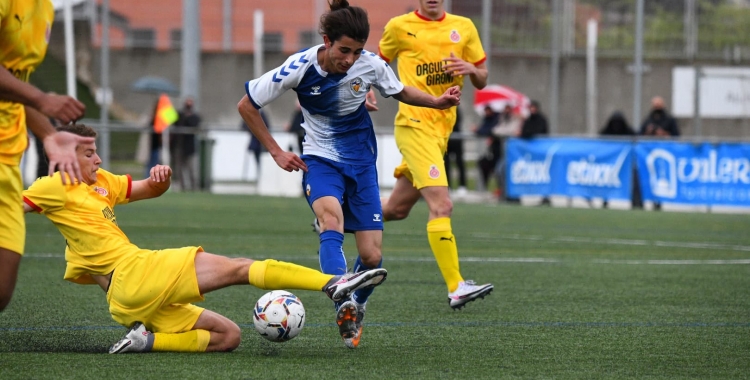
238,0,461,348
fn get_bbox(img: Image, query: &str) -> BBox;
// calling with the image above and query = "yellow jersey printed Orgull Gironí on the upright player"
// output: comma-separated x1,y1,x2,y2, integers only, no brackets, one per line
379,11,487,137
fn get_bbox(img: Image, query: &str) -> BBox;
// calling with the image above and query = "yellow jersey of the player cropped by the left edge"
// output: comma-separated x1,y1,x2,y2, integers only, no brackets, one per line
0,0,55,165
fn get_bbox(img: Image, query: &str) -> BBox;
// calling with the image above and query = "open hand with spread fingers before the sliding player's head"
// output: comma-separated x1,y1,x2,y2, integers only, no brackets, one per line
43,132,96,185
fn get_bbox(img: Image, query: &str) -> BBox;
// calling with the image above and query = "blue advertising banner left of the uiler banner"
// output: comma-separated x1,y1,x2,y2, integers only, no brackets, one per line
505,138,633,200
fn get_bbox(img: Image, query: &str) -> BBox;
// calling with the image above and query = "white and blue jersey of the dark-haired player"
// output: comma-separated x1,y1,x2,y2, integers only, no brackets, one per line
245,45,404,165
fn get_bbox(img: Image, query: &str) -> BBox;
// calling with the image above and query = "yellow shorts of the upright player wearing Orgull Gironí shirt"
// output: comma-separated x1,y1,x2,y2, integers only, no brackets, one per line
393,126,448,189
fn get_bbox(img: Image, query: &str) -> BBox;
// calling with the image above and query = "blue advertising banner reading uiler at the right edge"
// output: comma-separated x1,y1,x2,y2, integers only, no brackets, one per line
635,141,750,206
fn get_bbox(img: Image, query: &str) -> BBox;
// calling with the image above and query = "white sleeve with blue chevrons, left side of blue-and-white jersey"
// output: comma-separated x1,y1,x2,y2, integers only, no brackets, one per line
245,53,308,109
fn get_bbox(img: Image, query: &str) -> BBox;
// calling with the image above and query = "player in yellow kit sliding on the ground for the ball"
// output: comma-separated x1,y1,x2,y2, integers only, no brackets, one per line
23,124,387,354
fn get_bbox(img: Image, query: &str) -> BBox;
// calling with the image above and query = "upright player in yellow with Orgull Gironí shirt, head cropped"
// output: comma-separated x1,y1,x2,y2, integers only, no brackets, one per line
379,0,493,309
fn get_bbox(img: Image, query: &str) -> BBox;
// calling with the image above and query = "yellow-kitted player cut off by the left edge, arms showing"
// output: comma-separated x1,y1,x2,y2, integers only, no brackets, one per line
0,0,89,311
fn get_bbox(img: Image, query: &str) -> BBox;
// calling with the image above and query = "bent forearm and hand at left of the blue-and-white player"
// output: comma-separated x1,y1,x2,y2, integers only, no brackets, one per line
237,95,307,172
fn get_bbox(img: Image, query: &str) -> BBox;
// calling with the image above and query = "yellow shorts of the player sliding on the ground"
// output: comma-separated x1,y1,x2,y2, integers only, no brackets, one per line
107,247,204,333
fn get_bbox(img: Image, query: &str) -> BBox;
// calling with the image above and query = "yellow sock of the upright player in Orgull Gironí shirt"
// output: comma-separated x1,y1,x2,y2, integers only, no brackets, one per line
427,218,464,292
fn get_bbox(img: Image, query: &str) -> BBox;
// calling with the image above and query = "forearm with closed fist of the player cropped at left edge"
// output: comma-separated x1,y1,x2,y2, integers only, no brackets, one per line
0,70,86,124
